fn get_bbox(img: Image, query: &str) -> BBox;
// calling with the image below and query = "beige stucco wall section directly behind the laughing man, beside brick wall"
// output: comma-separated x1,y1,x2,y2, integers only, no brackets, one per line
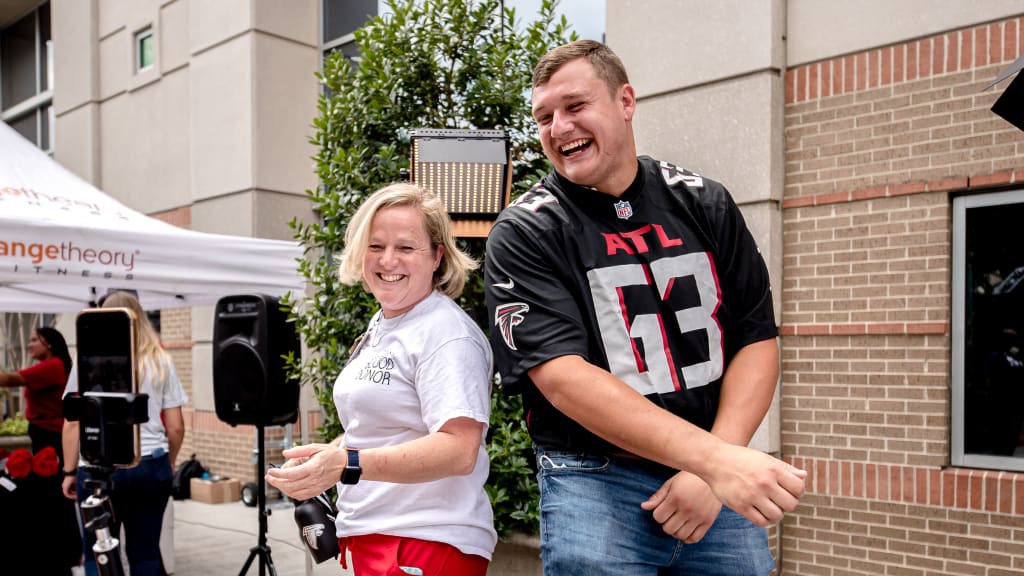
605,0,785,452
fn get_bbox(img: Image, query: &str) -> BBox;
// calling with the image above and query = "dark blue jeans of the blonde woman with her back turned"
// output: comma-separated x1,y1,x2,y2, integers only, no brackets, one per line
78,450,173,576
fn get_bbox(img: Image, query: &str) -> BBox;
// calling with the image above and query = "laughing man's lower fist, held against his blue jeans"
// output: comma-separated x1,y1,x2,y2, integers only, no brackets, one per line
640,471,722,544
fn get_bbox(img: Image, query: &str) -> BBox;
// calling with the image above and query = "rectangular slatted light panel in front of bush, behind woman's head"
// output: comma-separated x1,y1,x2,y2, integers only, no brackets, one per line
410,128,512,238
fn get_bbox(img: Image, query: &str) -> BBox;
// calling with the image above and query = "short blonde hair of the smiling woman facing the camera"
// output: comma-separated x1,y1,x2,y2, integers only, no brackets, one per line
338,182,479,298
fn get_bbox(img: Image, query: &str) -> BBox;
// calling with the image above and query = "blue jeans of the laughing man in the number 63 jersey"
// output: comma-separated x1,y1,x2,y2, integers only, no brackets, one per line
537,448,775,576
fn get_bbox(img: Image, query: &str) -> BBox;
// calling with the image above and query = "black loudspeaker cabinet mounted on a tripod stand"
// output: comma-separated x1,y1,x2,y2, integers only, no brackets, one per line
213,294,300,426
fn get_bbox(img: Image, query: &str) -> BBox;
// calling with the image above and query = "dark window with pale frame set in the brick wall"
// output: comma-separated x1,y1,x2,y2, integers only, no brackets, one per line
951,190,1024,471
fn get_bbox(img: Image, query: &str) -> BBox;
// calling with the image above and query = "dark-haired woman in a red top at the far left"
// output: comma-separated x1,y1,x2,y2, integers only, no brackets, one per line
0,326,82,574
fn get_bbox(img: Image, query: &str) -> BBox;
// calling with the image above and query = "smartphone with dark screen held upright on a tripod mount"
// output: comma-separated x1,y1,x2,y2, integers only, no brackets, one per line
77,308,138,394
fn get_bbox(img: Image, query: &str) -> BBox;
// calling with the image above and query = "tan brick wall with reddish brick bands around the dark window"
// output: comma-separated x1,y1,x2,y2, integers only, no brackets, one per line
780,18,1024,576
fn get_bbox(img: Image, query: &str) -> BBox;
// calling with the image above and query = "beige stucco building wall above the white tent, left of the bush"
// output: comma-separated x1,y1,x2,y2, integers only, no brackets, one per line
51,0,319,444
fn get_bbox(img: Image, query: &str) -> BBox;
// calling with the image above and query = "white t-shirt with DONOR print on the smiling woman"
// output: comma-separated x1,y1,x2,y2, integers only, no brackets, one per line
334,291,498,560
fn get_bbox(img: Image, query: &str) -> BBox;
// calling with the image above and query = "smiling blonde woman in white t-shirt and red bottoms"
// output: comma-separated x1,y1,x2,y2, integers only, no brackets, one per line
266,183,497,576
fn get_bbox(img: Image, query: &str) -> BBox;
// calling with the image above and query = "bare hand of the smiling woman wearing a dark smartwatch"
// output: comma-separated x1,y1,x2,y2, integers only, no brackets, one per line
265,444,345,500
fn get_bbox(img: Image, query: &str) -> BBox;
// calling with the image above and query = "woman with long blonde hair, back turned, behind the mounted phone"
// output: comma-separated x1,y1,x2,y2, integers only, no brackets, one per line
63,292,188,576
